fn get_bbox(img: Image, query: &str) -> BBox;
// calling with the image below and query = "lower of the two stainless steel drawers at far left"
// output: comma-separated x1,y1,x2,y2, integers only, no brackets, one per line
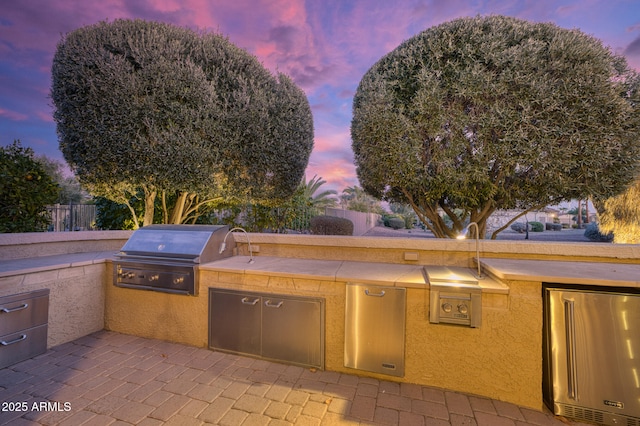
0,324,47,368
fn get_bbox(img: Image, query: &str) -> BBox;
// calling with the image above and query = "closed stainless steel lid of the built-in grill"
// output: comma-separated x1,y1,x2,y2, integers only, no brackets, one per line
118,225,229,263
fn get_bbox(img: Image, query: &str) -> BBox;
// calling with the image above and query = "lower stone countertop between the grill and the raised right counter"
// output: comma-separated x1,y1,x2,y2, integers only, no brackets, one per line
200,256,509,294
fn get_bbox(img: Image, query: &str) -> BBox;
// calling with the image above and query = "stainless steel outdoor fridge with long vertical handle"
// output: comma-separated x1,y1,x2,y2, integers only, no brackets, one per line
545,288,640,424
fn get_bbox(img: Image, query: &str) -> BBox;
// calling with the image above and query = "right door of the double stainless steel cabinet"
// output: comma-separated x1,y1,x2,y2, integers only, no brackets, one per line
262,295,324,368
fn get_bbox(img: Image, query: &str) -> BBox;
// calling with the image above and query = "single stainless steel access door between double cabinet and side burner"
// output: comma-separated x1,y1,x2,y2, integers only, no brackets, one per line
344,284,406,377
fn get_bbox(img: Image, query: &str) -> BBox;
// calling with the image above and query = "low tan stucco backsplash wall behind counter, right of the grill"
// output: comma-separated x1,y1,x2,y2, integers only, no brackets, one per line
234,233,640,266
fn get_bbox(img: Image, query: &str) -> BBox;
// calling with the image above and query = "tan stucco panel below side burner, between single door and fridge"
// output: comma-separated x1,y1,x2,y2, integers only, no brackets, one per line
405,282,542,410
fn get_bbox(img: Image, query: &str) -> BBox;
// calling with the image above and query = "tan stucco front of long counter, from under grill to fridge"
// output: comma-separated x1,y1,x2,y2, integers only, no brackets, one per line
105,264,542,410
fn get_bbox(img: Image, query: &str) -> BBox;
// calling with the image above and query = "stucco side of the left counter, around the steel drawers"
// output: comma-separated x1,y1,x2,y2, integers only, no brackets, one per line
0,262,106,348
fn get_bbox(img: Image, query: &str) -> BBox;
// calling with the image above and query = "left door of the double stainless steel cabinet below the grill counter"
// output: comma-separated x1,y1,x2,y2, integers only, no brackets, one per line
209,291,262,355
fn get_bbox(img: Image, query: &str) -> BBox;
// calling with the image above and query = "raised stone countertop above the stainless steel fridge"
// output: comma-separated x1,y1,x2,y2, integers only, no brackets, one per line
480,258,640,288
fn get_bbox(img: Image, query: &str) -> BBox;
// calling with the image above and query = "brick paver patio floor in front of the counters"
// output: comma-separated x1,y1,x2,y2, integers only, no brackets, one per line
0,331,592,426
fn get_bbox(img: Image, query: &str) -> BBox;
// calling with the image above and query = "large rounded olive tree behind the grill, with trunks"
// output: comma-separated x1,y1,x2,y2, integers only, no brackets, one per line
51,20,313,225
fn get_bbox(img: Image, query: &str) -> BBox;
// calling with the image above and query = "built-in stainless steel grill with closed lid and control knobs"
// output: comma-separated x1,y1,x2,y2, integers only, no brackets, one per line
113,225,235,295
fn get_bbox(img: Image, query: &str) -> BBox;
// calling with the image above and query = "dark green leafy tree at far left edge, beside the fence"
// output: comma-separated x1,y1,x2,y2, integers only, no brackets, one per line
0,141,59,233
